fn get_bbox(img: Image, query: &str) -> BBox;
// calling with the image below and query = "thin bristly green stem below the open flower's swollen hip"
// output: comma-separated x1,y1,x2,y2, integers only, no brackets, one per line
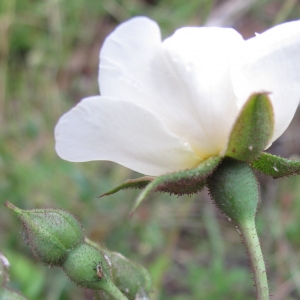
239,220,270,300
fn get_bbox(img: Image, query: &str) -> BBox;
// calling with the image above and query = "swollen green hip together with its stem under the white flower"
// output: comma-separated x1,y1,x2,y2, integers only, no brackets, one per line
208,158,269,300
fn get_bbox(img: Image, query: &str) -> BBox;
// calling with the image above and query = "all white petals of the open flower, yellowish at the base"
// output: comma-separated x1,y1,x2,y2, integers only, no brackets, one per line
55,17,300,176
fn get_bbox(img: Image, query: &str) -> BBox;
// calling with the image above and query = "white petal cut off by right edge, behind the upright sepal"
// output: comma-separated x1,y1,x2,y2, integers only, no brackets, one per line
232,21,300,142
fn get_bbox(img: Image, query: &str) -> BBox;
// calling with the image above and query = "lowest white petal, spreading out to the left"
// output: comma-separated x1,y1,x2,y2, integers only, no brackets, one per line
55,96,200,176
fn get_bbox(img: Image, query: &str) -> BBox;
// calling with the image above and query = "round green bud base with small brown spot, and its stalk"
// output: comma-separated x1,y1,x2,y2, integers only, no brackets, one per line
63,243,127,300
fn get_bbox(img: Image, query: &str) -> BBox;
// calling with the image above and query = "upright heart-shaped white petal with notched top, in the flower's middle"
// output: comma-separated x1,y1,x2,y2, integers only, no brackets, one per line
99,18,242,159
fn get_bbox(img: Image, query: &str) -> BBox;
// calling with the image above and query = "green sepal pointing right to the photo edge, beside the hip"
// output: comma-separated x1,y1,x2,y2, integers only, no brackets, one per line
251,153,300,178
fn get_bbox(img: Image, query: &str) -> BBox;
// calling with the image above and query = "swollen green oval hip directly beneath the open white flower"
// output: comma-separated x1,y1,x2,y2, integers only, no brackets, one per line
207,158,260,225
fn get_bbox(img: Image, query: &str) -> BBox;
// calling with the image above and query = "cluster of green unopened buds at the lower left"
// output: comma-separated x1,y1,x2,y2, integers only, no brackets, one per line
5,202,151,300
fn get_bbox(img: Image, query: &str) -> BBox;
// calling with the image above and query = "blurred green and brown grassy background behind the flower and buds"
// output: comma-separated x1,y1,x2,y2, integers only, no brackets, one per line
0,0,300,300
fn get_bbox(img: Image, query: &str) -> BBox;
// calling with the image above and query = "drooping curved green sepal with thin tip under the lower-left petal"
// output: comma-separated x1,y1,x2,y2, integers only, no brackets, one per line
130,156,222,216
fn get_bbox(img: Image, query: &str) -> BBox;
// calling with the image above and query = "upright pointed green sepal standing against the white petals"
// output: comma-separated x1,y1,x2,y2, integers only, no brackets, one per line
225,93,274,162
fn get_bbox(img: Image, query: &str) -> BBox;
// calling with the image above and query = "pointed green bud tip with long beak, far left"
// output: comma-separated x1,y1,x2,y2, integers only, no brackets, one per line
5,202,84,266
